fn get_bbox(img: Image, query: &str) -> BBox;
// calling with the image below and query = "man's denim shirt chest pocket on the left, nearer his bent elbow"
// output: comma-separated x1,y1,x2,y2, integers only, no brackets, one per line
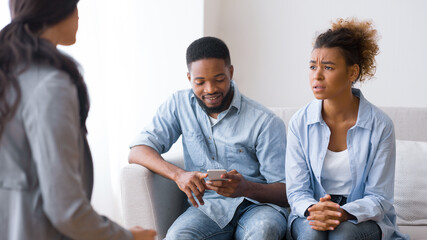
183,132,209,168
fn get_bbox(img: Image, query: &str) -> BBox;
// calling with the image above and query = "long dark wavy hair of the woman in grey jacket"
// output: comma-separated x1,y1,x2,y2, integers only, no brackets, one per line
0,0,89,138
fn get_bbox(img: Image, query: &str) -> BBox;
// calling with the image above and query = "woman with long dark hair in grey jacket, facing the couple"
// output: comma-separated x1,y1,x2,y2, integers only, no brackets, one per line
0,0,155,239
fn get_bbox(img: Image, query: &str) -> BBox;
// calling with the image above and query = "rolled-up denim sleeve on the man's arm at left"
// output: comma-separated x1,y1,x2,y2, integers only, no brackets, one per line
130,95,181,154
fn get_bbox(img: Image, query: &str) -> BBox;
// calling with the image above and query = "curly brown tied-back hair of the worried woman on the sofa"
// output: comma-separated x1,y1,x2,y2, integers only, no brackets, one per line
313,18,379,82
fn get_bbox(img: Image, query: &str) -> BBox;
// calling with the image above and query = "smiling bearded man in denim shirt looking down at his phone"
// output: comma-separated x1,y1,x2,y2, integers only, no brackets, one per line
129,37,288,240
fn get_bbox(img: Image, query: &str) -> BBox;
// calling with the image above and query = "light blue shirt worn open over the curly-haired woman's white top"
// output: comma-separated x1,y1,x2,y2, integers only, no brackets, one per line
286,89,405,239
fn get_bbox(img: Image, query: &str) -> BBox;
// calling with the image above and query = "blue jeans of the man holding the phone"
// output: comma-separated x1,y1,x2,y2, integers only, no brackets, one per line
166,200,287,240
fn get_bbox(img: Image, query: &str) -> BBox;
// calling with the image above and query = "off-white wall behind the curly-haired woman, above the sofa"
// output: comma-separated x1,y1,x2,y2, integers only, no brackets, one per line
204,0,427,107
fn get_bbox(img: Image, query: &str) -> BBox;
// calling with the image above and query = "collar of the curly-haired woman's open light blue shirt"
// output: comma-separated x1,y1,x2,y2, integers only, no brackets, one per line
307,88,372,129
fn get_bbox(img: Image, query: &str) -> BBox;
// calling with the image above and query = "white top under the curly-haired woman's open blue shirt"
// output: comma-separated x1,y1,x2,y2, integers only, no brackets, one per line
321,149,351,197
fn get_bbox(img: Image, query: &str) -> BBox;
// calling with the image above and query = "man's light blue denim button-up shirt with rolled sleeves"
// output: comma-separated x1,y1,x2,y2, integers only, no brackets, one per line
131,81,287,228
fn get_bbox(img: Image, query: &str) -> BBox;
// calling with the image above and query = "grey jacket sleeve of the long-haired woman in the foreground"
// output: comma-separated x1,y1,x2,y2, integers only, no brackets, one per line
22,71,133,239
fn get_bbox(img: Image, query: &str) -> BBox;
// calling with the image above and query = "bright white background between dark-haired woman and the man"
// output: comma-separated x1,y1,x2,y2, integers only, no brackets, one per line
61,0,203,223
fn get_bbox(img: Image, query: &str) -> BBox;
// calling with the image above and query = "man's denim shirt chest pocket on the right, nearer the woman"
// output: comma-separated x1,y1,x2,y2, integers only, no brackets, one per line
224,146,260,176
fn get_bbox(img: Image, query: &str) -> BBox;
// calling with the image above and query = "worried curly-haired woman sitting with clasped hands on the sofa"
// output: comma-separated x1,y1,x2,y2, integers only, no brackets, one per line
286,19,406,240
